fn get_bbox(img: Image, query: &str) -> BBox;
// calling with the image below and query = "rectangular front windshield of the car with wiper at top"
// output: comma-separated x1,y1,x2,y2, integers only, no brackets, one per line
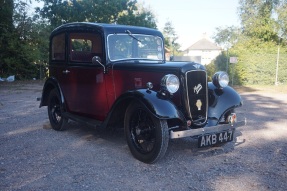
108,31,164,61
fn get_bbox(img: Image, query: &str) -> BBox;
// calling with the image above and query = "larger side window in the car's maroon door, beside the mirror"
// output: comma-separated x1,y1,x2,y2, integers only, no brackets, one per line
70,33,102,63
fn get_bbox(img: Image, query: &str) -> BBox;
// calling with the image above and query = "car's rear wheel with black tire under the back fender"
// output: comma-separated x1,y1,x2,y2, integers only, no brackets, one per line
48,89,68,131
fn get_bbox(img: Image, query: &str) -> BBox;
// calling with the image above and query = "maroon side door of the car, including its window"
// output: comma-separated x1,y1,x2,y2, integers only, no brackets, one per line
62,31,108,120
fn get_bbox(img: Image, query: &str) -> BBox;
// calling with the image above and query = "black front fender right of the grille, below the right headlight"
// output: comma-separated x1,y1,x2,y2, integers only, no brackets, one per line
208,82,242,125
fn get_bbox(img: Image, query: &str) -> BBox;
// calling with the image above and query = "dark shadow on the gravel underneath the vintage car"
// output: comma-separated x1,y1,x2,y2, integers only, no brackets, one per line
43,121,244,160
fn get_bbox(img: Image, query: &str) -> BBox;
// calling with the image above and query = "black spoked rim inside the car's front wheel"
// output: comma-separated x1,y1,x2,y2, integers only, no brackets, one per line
130,109,156,154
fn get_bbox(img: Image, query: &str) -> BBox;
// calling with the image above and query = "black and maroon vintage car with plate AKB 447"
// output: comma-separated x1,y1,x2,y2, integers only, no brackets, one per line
40,23,244,163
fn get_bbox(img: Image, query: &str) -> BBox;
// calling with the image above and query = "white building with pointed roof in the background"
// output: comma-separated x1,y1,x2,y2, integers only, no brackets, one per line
183,37,222,65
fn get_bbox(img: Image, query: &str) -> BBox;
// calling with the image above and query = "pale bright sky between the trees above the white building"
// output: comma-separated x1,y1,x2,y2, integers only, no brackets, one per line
142,0,240,50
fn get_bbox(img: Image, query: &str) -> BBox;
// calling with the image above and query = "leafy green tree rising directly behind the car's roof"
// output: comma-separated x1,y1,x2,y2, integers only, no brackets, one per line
36,0,156,28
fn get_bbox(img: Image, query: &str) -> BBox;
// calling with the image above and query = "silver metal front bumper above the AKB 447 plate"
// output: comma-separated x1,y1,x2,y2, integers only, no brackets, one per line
170,119,246,139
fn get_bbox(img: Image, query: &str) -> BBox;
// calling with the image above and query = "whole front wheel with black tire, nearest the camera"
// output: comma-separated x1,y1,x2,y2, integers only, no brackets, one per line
125,102,169,163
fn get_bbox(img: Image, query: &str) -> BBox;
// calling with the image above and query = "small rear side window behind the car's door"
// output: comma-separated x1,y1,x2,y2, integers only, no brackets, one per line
51,33,65,60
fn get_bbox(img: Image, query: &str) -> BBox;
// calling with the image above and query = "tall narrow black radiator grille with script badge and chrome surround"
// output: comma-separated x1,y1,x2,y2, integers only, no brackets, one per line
185,70,208,125
